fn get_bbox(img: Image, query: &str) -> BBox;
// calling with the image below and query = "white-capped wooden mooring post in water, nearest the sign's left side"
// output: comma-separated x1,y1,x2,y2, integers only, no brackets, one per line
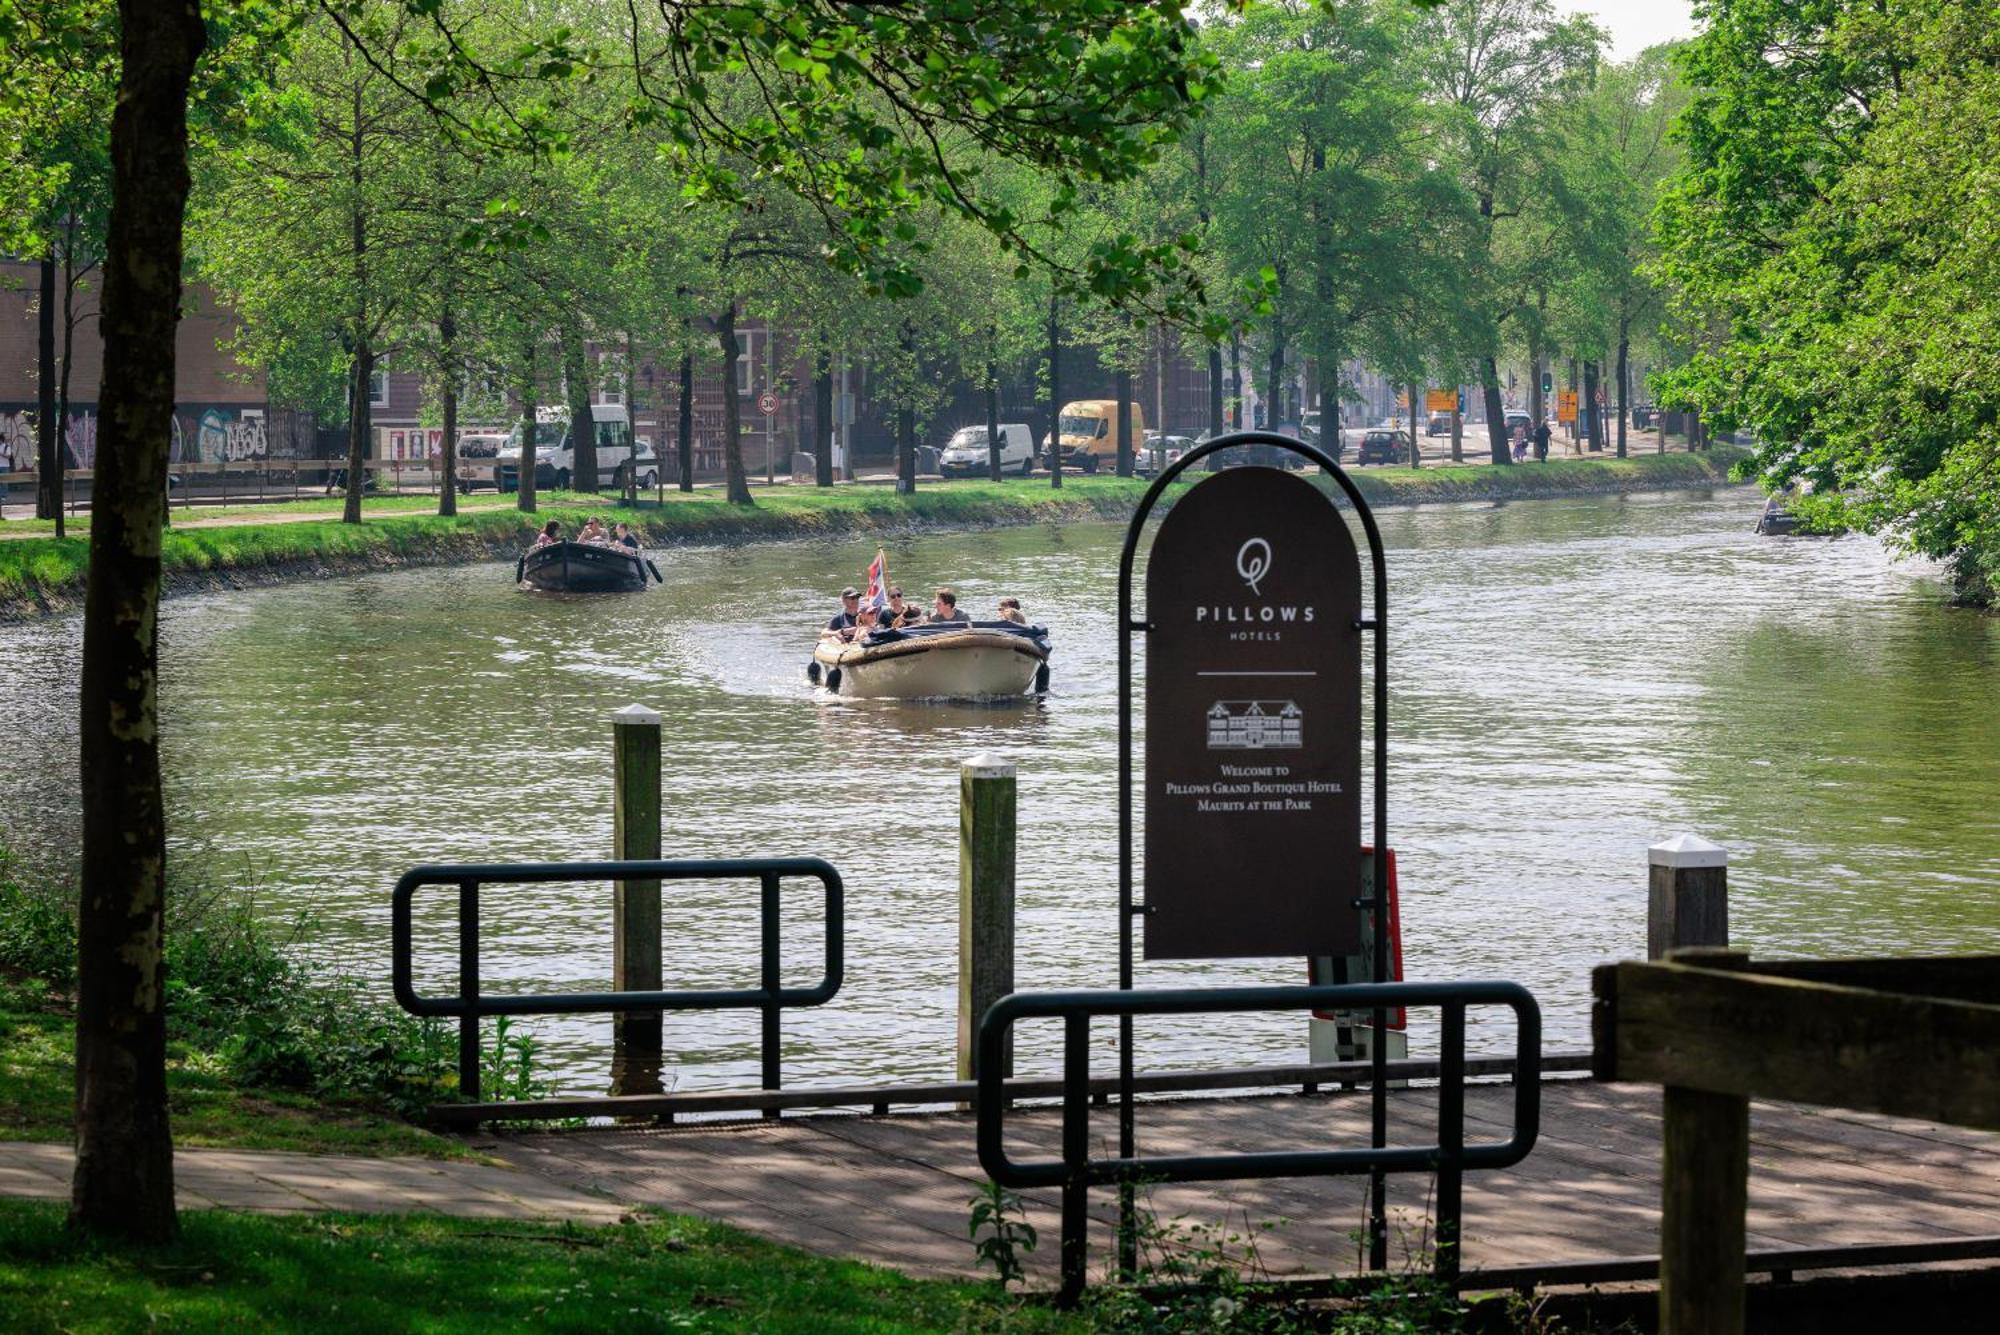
958,755,1014,1079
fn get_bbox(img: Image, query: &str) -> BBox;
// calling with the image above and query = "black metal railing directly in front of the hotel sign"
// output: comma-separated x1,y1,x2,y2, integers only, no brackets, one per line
978,983,1542,1301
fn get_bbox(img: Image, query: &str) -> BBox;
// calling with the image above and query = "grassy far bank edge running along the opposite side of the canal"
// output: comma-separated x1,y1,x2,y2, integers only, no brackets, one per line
0,448,1744,622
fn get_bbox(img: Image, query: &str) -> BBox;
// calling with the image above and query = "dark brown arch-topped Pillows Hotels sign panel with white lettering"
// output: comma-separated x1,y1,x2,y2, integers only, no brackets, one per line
1144,468,1362,959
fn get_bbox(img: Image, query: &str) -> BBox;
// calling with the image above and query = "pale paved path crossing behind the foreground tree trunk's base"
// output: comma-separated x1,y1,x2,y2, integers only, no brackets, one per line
0,1141,630,1223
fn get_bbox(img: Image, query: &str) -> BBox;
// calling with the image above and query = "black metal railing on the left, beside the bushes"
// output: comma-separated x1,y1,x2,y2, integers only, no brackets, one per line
390,857,846,1099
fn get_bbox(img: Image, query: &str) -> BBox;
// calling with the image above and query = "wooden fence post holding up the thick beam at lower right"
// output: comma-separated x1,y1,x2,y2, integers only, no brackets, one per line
1660,947,1750,1335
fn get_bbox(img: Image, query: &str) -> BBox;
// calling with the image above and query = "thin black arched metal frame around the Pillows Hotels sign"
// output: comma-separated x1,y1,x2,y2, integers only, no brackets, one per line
1118,430,1390,1275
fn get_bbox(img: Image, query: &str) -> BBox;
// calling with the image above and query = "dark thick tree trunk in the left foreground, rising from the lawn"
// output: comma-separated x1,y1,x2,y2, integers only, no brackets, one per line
70,0,206,1243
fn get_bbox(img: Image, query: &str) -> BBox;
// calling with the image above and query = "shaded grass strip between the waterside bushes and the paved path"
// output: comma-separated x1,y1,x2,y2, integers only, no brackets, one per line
0,971,478,1159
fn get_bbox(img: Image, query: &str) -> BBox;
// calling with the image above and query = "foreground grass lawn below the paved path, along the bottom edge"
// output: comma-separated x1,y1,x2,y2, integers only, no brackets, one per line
0,1201,1086,1335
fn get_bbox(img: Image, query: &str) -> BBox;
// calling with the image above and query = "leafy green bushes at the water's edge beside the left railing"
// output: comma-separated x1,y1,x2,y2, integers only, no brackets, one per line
0,851,456,1115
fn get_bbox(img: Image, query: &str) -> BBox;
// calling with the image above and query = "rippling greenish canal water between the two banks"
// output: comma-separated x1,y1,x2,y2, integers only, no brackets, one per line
0,488,2000,1091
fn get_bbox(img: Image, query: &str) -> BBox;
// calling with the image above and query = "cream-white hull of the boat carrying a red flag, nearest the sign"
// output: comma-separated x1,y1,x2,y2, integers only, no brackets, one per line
806,622,1048,699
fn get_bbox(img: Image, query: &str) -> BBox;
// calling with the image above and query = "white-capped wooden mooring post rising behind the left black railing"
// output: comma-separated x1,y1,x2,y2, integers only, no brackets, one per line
612,705,662,1093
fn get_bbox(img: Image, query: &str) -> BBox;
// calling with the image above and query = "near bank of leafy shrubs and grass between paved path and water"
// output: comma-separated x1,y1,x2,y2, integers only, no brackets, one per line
0,857,472,1157
